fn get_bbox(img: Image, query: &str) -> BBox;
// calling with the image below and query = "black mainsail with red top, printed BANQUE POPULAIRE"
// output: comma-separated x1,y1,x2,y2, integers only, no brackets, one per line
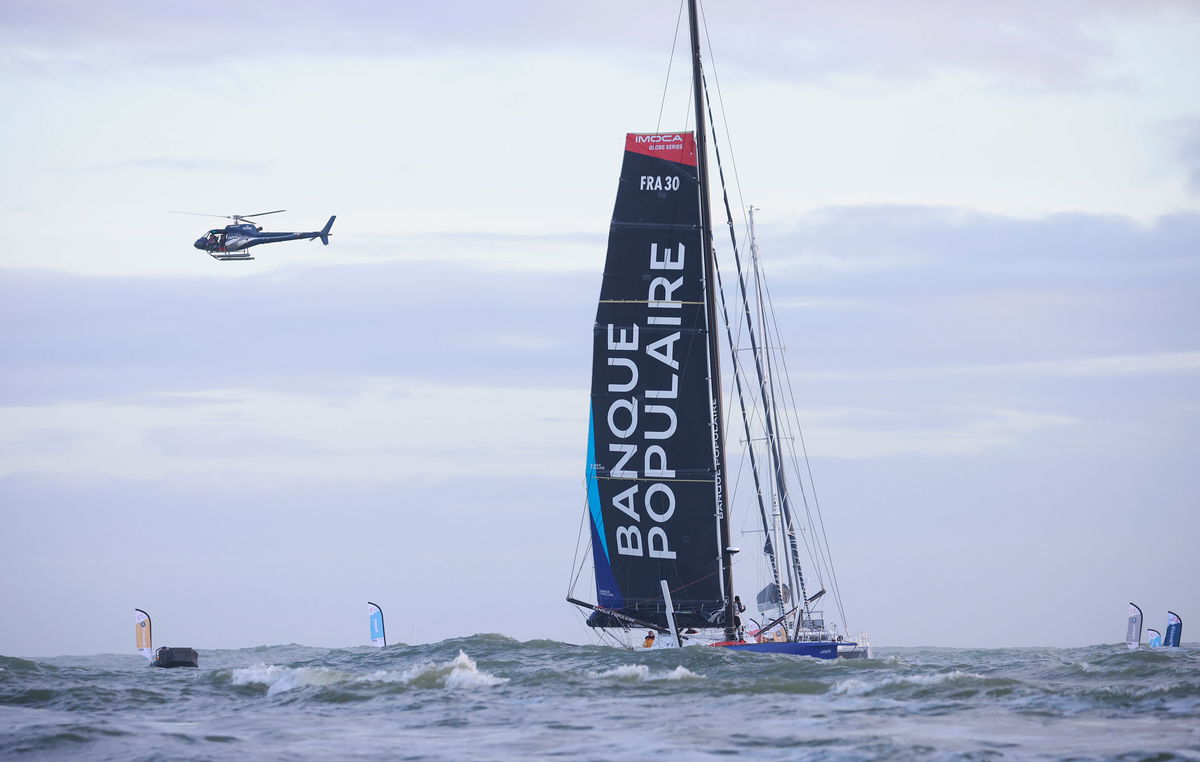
587,132,725,628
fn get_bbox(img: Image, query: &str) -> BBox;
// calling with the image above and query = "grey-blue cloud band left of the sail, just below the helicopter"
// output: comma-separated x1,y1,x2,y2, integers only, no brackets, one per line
0,262,599,404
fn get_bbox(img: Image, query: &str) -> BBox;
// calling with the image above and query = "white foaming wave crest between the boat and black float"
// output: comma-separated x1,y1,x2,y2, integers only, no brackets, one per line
229,650,508,696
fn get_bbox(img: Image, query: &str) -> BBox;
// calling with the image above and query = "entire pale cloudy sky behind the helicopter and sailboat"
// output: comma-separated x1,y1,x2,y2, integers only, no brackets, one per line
0,0,1200,655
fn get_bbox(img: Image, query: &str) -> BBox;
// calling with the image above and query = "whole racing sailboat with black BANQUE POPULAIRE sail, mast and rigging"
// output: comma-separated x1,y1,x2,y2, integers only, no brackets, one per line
566,0,870,659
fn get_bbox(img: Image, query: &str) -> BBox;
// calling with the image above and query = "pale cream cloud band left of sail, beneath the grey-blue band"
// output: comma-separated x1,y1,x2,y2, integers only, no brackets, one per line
0,377,587,479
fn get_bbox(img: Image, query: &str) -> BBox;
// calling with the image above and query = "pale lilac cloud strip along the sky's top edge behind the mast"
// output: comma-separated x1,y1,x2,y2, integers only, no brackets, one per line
0,0,1195,88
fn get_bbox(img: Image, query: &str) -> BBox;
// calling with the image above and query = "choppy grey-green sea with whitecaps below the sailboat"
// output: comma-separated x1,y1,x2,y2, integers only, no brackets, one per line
0,635,1200,762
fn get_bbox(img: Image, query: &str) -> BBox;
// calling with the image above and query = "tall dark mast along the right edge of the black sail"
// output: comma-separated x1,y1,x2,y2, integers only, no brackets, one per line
688,0,737,640
